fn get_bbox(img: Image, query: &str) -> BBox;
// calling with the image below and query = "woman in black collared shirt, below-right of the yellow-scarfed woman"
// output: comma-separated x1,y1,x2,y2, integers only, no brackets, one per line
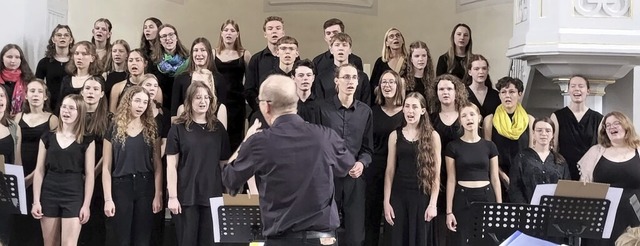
509,117,571,204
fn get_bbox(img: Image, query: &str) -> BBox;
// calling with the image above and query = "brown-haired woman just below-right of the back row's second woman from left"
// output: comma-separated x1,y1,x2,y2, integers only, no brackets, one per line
103,39,131,99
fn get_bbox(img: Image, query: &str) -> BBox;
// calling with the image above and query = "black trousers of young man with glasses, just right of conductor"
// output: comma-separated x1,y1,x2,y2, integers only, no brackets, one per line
335,176,365,246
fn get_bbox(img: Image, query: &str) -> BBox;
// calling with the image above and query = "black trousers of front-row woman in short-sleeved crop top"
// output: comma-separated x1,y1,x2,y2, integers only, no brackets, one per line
447,184,496,246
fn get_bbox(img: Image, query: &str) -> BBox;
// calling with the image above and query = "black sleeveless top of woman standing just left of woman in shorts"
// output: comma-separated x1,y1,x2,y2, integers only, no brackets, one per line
18,114,53,175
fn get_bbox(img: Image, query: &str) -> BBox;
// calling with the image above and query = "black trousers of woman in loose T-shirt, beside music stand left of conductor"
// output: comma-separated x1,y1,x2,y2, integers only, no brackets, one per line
171,205,213,246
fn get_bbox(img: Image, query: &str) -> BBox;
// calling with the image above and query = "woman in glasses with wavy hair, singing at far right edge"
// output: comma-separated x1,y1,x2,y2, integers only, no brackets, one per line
578,111,640,246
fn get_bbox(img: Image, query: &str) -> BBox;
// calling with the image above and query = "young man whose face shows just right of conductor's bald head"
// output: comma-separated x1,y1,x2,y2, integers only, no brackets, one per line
291,59,320,123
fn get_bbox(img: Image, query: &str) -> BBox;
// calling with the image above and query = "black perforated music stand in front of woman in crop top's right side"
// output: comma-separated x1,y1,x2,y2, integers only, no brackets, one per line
469,202,549,246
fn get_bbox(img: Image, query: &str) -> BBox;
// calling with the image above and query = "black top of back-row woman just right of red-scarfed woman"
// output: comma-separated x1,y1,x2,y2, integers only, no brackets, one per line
36,57,69,107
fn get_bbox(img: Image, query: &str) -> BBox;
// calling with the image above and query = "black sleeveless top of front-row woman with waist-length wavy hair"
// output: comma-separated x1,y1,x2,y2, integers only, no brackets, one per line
392,128,420,190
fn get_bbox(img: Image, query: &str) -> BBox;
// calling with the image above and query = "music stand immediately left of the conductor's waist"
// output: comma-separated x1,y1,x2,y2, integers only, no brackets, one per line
214,205,264,243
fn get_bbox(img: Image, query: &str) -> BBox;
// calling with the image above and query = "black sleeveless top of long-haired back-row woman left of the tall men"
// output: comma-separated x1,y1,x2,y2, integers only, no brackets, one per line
215,52,247,106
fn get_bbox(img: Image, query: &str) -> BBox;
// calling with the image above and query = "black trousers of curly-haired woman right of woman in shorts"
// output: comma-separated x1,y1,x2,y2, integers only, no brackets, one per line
107,173,155,246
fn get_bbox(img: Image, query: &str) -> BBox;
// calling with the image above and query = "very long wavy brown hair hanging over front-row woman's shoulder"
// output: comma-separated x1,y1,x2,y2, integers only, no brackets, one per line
405,92,440,195
